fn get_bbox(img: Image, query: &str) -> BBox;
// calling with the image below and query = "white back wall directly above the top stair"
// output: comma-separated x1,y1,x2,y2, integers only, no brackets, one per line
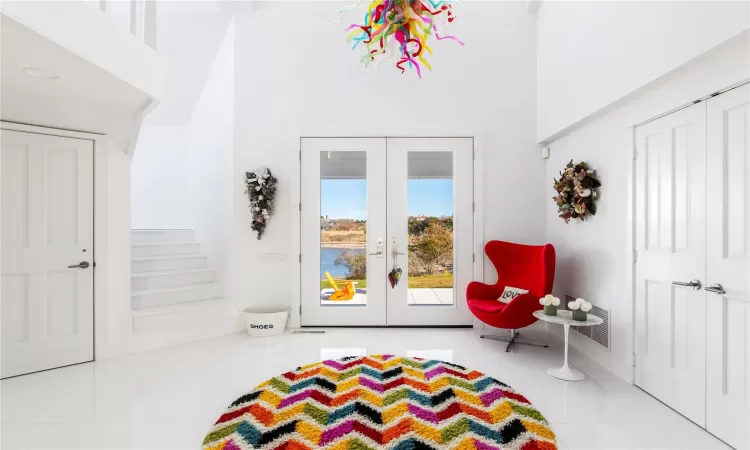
131,125,193,229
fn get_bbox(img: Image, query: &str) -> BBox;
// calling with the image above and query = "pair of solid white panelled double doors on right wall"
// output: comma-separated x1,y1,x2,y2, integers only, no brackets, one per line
635,84,750,449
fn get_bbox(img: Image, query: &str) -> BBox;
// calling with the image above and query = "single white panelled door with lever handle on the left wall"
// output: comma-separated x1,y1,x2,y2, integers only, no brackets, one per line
0,130,94,378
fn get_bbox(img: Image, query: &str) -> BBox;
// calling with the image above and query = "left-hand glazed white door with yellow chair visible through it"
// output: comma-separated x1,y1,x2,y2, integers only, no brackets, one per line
301,138,386,326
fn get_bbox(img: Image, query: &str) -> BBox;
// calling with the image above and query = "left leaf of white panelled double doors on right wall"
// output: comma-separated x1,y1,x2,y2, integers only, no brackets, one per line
635,102,706,426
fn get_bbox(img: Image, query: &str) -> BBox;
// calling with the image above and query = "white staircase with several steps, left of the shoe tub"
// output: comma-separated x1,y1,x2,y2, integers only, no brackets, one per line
130,230,221,311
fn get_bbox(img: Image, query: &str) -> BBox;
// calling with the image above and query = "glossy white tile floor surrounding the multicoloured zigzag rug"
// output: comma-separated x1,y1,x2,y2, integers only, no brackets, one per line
0,326,727,450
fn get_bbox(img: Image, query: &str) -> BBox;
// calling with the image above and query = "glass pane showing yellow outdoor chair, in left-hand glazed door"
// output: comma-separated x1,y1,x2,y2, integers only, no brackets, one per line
320,151,367,306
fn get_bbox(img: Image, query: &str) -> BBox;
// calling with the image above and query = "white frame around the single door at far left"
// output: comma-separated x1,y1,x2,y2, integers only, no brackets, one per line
0,121,112,361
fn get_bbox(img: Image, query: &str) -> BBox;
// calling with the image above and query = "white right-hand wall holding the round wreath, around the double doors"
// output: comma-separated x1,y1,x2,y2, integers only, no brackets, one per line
544,33,750,380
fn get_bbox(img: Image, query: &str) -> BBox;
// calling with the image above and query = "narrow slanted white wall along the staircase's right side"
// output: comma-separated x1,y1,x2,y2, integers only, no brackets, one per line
186,20,234,292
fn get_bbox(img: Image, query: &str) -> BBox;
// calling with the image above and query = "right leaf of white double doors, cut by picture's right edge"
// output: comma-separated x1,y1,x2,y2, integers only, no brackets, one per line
706,85,750,449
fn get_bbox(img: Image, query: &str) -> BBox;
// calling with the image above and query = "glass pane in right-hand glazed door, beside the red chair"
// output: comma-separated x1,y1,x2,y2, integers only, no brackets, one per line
407,151,453,305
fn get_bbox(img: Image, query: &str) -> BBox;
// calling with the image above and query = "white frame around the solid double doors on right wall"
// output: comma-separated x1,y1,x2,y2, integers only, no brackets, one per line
623,79,750,386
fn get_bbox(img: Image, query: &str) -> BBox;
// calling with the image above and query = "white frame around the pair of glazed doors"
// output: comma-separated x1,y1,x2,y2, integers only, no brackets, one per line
289,134,485,328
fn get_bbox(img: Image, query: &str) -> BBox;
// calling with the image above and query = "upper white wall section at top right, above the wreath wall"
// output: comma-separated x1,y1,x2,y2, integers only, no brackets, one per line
537,0,750,142
